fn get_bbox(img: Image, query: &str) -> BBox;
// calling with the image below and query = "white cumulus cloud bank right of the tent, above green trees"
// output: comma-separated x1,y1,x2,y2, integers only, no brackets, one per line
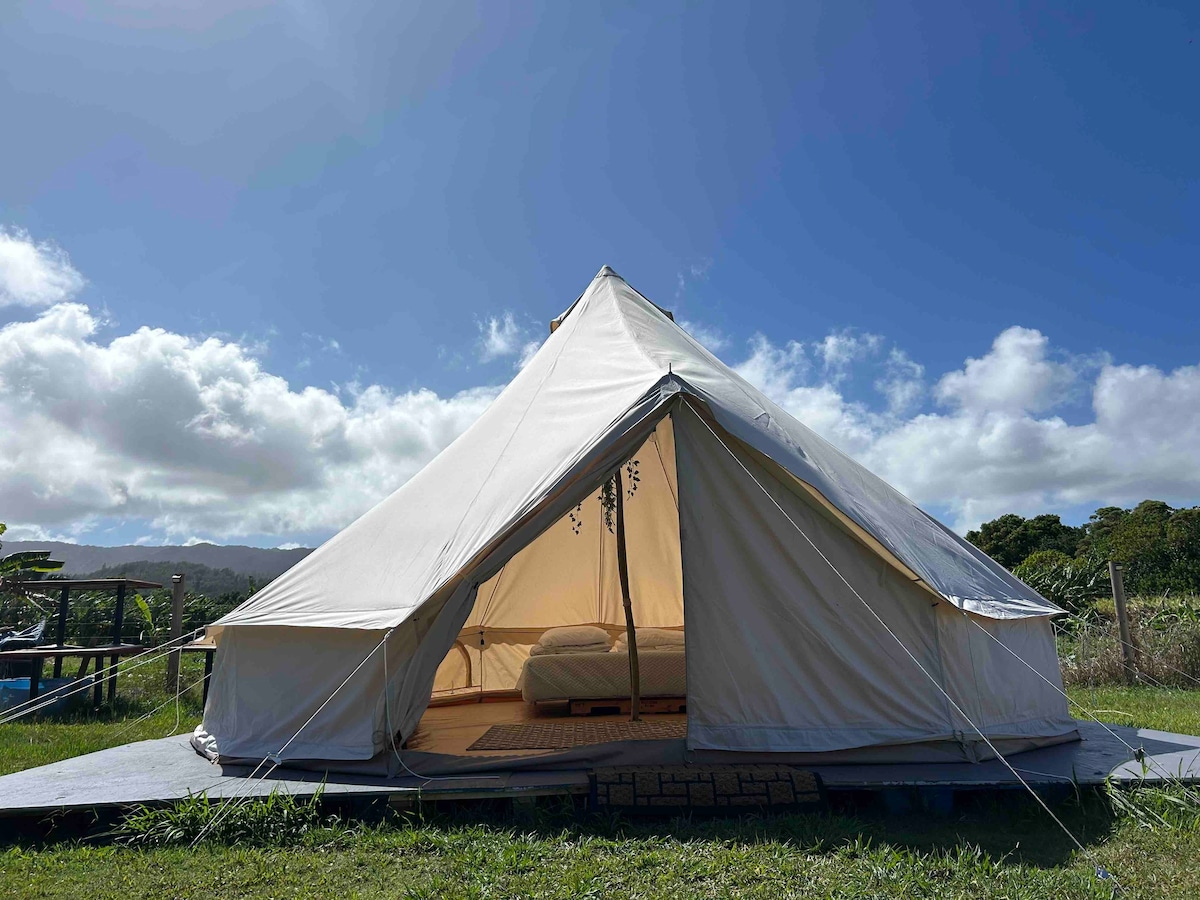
737,328,1200,530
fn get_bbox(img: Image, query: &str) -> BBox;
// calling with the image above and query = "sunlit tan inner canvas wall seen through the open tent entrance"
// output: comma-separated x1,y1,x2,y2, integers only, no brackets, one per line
414,416,684,743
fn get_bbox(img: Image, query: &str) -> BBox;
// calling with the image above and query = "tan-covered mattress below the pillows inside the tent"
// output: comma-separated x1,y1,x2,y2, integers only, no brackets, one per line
518,650,688,703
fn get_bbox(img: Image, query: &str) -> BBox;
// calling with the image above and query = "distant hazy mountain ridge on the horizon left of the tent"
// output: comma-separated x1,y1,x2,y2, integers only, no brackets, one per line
0,541,312,581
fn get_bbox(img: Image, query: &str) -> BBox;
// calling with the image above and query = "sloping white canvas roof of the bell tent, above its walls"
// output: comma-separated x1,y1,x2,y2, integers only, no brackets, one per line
216,266,1061,629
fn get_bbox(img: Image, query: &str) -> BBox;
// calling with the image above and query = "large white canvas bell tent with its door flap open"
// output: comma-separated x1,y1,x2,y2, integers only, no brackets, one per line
200,266,1075,761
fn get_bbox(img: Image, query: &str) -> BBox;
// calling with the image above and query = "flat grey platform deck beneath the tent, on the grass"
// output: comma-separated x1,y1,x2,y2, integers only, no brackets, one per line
0,724,1200,817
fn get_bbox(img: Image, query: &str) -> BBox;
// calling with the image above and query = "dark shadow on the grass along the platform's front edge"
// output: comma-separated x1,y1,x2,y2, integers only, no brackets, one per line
0,788,1118,869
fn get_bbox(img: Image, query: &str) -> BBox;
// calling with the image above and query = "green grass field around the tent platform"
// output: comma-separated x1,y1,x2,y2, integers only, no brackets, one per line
0,659,1200,900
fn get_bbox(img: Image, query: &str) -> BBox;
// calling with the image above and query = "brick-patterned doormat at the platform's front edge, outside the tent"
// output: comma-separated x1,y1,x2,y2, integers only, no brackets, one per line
588,766,826,816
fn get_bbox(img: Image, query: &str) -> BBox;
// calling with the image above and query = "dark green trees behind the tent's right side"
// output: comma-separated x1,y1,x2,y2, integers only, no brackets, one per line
966,500,1200,607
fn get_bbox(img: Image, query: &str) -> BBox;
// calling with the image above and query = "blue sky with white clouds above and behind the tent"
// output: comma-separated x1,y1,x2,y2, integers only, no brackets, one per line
0,0,1200,544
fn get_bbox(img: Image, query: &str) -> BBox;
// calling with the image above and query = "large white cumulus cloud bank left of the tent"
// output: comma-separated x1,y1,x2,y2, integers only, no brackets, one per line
0,304,499,540
